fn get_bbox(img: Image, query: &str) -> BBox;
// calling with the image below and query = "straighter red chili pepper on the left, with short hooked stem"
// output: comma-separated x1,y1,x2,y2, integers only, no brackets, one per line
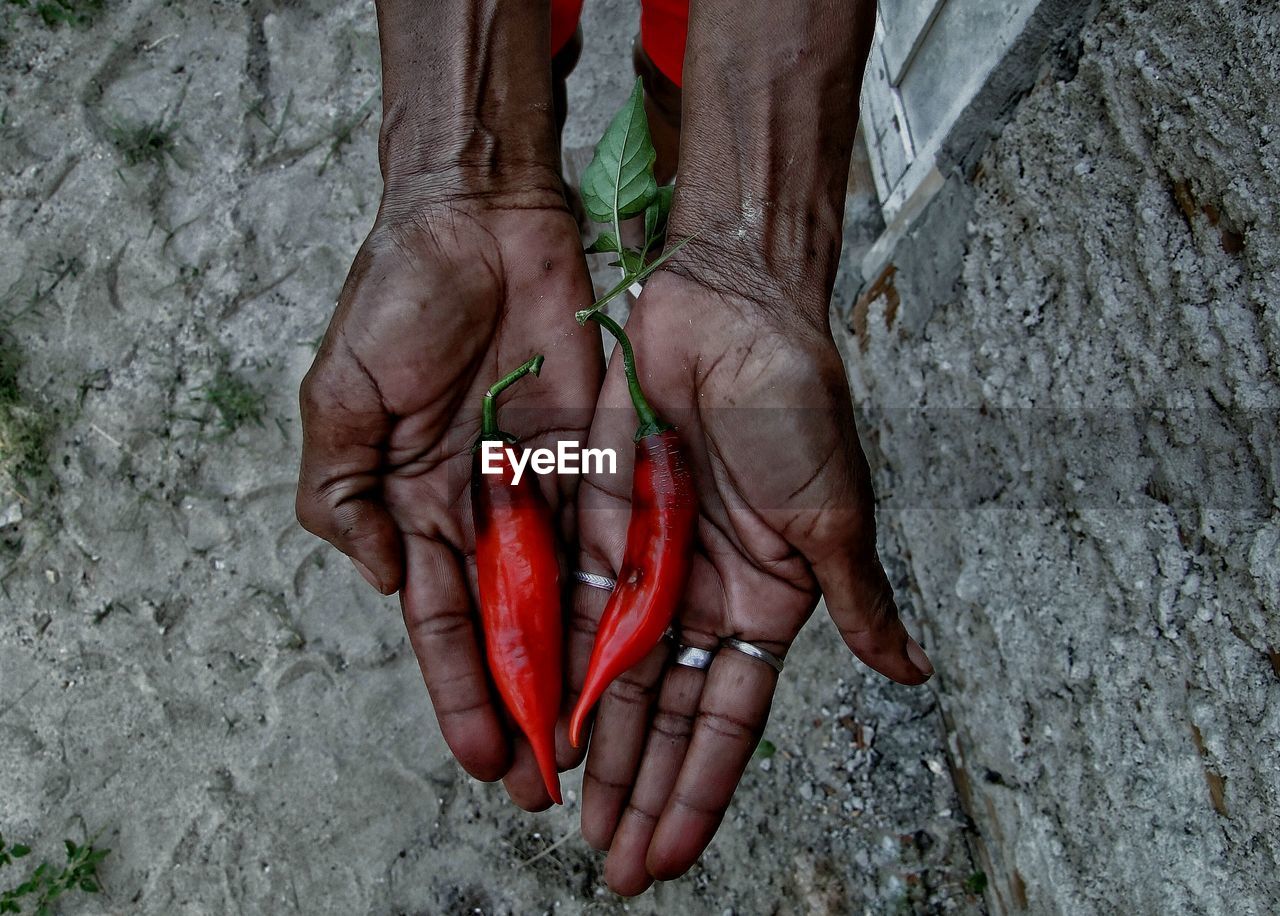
471,356,563,805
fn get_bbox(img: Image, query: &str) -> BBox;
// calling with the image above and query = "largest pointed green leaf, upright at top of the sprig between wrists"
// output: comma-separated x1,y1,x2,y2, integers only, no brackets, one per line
582,79,658,223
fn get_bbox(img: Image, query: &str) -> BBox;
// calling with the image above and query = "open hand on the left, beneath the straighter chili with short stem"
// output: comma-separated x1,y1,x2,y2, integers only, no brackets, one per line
297,191,603,809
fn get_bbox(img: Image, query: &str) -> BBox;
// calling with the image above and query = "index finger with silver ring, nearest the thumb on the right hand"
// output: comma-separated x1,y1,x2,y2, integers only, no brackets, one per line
645,642,785,881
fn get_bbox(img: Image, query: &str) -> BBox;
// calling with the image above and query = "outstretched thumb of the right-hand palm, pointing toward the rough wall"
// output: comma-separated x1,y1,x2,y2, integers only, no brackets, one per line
814,541,933,684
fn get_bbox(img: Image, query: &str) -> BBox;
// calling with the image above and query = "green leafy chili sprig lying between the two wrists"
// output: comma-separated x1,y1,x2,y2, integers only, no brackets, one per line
575,79,692,324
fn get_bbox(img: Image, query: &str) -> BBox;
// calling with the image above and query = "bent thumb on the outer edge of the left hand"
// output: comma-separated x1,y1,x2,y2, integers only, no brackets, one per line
296,358,404,595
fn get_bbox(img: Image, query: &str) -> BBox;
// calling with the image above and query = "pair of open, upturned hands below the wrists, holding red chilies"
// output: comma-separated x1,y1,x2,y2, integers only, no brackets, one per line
297,197,932,894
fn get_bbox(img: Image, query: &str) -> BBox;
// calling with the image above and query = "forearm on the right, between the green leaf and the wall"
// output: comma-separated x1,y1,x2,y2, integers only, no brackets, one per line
669,0,876,328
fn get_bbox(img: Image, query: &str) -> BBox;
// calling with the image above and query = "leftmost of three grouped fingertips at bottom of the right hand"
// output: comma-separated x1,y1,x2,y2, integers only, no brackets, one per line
582,641,669,849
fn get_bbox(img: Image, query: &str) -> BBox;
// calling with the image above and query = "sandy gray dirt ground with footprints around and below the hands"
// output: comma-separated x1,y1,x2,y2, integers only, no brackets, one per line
0,0,982,913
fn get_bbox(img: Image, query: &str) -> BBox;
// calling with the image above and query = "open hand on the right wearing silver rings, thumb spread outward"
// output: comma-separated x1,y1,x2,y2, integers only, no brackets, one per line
562,271,932,894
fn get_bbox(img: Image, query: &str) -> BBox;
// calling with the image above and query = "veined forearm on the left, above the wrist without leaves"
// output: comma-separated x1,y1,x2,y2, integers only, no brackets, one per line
376,0,562,205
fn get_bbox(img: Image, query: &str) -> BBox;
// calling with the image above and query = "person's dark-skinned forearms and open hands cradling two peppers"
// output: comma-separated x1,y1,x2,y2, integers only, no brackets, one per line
298,0,932,894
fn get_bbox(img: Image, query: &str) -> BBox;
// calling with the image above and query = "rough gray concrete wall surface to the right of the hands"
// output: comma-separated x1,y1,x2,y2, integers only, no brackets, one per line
837,0,1280,913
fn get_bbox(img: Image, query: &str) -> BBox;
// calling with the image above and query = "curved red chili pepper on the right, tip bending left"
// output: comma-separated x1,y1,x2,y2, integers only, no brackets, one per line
568,312,698,747
